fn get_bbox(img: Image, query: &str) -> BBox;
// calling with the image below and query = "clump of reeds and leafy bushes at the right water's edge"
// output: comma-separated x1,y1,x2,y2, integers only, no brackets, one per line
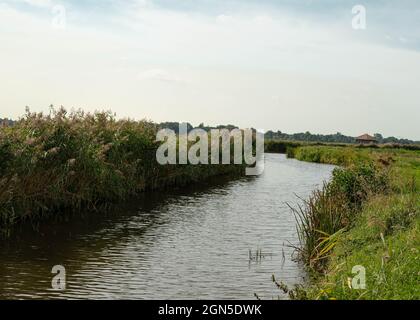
292,164,388,271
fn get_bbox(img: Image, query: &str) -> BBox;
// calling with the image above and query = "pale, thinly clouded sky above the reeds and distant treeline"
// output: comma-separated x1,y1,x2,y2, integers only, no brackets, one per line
0,0,420,140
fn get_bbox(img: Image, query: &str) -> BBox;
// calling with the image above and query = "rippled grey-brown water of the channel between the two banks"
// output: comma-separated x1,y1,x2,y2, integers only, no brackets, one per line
0,154,333,299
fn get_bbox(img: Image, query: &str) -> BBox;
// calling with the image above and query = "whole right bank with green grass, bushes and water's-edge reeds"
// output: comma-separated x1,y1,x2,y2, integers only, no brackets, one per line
292,146,420,299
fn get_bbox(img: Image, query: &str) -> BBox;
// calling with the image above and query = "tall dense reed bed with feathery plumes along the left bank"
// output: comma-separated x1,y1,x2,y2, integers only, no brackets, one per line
0,110,244,230
